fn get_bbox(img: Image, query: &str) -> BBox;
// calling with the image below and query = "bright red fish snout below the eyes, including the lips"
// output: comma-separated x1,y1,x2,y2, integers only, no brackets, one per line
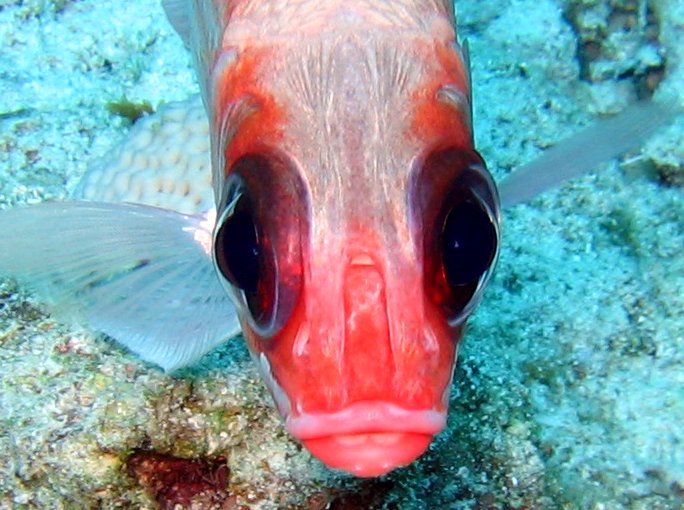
245,245,461,477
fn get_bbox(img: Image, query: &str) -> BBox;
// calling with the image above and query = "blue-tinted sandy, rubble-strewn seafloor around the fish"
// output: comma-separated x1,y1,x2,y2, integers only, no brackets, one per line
0,0,684,510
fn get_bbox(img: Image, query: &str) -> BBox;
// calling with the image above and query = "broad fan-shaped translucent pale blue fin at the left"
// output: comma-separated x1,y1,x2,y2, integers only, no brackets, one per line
0,202,239,370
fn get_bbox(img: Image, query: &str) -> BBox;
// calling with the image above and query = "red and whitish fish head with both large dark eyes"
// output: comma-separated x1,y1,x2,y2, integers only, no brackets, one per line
206,8,499,476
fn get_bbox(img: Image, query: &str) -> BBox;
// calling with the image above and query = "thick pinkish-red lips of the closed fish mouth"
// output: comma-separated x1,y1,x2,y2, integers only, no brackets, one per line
285,401,446,477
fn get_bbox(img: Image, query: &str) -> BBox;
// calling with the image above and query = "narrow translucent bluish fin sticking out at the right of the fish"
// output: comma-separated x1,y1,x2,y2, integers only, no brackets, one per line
499,101,681,207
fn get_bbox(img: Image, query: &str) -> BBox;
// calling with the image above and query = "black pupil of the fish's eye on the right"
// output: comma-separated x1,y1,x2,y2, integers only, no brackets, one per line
442,199,497,287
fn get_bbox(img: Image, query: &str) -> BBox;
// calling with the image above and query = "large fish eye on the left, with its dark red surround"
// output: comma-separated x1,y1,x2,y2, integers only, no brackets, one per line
213,153,308,338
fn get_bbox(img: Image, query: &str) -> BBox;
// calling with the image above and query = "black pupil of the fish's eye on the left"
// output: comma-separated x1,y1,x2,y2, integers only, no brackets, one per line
217,210,259,292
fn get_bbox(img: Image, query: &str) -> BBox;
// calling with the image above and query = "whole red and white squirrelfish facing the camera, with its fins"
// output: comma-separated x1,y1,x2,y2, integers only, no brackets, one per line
0,0,672,476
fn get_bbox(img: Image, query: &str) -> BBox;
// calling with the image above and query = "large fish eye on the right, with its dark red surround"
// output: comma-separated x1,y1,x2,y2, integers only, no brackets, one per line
409,147,499,326
